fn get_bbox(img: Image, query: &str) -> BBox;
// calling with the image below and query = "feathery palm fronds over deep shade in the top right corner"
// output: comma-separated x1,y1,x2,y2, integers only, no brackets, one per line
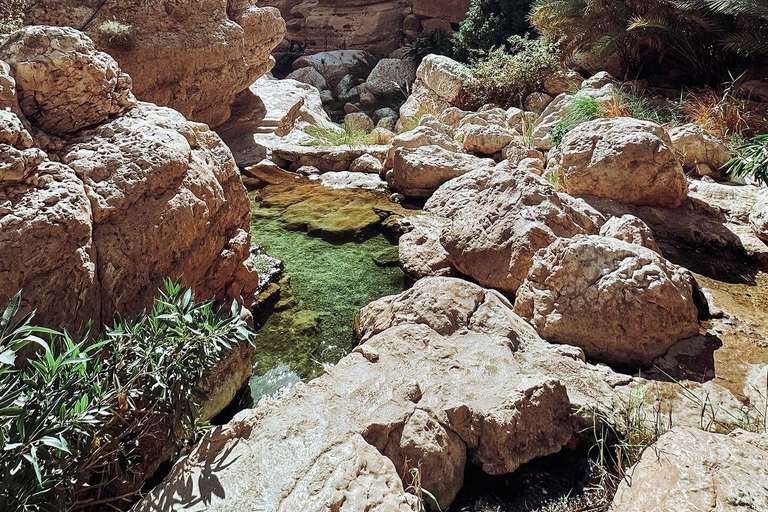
531,0,768,83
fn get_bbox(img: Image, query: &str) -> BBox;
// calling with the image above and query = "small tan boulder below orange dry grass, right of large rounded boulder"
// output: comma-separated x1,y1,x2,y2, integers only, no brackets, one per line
669,123,731,171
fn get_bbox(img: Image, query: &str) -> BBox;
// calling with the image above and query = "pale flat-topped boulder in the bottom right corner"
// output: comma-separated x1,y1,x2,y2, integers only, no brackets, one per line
610,427,768,512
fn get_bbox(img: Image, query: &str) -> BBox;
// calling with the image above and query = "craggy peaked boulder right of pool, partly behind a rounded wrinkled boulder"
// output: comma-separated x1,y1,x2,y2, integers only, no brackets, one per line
424,166,602,296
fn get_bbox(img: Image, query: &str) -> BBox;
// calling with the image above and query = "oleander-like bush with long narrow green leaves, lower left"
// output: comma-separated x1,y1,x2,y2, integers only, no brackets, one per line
0,282,254,511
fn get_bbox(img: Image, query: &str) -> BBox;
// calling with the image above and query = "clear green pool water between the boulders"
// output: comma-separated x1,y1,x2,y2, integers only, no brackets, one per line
251,196,405,384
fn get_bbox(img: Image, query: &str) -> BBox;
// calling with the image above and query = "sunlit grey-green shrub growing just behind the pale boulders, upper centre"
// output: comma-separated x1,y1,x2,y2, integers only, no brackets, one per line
462,36,558,110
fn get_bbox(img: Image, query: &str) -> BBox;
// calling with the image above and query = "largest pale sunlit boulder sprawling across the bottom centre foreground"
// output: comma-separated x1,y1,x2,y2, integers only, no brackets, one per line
135,279,573,512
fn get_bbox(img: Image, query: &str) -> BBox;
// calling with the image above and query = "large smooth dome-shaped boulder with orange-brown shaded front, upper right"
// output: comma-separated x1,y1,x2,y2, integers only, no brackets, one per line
547,117,688,208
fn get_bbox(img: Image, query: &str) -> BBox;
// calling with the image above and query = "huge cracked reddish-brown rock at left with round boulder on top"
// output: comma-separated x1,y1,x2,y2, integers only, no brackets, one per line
0,27,258,332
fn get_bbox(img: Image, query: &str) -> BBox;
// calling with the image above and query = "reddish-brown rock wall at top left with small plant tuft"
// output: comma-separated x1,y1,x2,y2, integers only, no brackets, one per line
26,0,285,126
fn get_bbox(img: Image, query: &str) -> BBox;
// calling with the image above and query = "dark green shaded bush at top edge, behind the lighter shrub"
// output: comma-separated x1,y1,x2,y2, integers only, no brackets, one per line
455,0,531,60
